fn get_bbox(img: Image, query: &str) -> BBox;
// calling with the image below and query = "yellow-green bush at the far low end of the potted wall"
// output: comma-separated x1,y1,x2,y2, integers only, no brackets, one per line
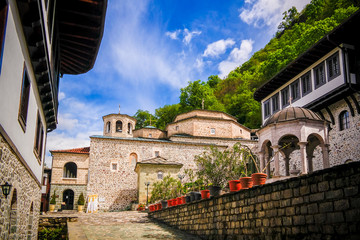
150,175,182,203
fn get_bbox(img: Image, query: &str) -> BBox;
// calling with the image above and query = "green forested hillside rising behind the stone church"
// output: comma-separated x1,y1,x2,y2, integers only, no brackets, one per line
134,0,360,129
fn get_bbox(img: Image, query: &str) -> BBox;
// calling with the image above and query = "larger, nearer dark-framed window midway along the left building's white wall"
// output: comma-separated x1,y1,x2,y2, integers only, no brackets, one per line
18,66,30,131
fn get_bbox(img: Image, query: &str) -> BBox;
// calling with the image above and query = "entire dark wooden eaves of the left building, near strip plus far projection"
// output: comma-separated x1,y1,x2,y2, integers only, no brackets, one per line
16,0,107,132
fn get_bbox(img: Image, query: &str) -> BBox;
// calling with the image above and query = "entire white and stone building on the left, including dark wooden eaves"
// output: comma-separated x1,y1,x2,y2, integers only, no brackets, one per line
0,0,107,239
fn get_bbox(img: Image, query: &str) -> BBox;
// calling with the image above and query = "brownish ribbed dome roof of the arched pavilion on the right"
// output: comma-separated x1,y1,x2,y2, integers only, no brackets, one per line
263,107,325,127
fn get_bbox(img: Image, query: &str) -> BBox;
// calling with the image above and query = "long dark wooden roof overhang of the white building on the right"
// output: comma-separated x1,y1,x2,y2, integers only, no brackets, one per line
254,10,360,102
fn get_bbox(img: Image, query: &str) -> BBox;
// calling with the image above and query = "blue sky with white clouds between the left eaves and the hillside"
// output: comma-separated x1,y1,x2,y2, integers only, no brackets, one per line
46,0,310,165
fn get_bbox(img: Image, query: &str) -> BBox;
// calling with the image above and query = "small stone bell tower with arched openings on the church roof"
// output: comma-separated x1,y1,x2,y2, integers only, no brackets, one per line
103,113,136,138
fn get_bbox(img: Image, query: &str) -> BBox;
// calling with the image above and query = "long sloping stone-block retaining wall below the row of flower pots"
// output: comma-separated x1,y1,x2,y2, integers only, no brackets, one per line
149,162,360,240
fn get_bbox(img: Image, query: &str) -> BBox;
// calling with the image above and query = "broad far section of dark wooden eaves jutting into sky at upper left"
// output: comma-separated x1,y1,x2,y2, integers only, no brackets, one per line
56,0,107,74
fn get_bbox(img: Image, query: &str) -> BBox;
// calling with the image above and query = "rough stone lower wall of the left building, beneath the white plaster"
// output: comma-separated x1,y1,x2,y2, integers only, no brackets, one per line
0,135,41,240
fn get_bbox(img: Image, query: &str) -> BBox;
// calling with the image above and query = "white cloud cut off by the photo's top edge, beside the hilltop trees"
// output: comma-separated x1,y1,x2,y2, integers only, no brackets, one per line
239,0,310,31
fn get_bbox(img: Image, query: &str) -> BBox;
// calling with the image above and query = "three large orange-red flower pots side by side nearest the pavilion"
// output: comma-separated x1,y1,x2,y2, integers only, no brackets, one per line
229,173,267,192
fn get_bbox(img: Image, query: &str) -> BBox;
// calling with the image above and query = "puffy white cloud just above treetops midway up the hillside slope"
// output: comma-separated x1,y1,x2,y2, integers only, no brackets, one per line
219,39,254,78
